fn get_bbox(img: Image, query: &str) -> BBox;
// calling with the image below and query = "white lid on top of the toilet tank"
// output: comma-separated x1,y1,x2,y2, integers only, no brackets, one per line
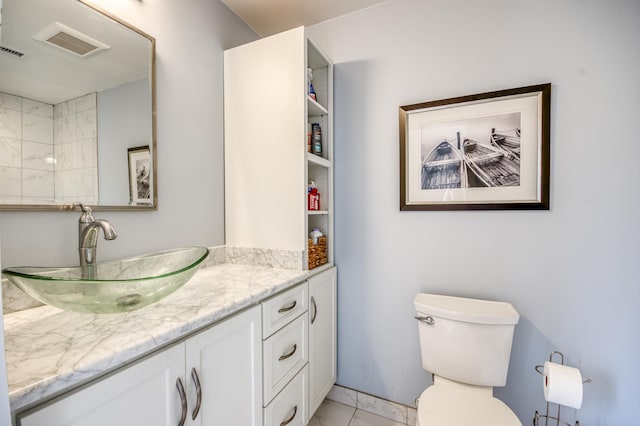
415,293,520,325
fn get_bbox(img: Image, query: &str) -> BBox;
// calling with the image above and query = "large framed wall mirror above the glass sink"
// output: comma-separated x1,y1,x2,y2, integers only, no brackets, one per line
0,0,158,210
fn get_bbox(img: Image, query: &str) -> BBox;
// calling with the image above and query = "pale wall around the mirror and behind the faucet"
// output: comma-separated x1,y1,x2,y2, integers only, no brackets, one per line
0,0,258,266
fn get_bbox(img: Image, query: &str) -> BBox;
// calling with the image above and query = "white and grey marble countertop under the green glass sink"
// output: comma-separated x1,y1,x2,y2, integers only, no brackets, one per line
4,264,310,411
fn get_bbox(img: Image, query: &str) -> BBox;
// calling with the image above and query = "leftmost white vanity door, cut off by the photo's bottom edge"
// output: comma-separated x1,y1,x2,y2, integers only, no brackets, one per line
18,344,184,426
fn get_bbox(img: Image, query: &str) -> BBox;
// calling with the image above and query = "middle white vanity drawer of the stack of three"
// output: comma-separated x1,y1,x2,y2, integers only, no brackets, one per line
262,315,309,406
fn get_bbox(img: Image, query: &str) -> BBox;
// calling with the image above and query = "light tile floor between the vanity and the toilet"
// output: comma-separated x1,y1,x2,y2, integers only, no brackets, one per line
309,399,405,426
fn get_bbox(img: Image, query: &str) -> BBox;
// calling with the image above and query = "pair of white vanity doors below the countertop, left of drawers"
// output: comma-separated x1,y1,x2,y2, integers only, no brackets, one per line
17,306,263,426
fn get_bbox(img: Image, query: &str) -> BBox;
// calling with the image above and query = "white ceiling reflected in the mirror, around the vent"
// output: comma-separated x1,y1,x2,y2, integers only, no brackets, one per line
0,0,151,105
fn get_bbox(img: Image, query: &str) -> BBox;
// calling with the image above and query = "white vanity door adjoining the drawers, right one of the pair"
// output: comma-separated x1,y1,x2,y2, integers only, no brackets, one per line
185,306,262,426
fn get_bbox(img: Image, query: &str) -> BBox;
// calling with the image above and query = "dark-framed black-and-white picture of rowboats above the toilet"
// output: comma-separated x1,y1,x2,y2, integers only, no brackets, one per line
399,83,551,210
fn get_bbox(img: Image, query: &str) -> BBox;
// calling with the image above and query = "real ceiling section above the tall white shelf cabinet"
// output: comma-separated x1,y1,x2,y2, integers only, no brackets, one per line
222,0,386,37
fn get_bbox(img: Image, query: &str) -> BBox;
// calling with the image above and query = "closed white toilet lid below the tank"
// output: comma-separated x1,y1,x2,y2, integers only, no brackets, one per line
417,385,522,426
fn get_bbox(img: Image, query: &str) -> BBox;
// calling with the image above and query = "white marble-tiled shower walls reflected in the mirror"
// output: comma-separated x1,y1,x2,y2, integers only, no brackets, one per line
0,93,98,204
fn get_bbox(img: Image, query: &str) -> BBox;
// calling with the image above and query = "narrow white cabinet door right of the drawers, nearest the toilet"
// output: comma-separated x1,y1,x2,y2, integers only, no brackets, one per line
309,268,337,417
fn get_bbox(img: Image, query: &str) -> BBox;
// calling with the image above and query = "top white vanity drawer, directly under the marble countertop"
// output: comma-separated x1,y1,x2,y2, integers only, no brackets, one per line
262,282,309,339
